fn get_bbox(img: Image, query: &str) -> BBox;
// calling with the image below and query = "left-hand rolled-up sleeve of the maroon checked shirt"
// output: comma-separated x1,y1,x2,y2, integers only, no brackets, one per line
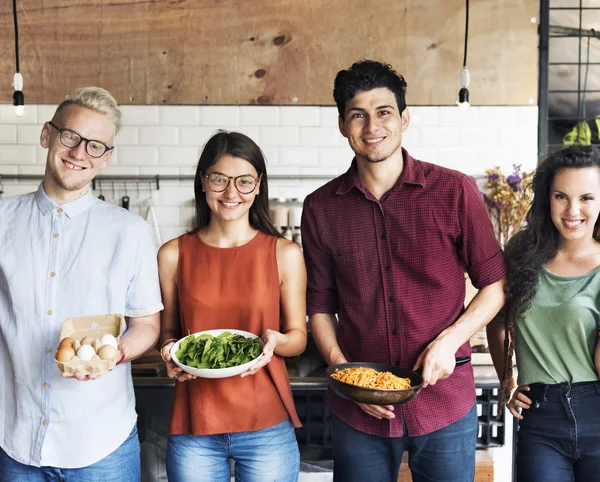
301,196,338,316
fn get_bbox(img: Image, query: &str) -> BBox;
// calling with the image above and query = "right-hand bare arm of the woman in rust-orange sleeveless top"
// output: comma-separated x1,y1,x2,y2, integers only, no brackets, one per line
242,239,307,377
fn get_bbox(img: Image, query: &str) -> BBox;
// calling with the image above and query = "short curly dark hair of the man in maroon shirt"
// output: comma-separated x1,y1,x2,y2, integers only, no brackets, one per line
333,60,406,120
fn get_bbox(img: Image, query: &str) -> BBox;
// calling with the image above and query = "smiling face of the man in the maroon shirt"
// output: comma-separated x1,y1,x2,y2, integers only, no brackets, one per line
339,87,410,167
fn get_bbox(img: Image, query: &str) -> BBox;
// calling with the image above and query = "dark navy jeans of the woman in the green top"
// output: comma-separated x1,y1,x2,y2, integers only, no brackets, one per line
516,382,600,482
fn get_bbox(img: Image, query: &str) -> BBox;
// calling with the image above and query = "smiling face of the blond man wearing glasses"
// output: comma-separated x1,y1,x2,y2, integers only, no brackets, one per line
40,105,115,201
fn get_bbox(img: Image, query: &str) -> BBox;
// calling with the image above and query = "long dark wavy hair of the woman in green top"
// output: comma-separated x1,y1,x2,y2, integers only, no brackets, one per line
500,146,600,403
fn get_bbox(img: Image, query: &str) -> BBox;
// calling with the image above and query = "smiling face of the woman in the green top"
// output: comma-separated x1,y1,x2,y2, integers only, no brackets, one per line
550,167,600,242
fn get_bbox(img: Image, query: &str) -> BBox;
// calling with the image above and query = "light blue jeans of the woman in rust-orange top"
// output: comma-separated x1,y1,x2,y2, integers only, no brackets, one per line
167,419,300,482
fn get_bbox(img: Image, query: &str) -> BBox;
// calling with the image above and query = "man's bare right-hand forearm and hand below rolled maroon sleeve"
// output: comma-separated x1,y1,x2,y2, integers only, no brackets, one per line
413,280,504,386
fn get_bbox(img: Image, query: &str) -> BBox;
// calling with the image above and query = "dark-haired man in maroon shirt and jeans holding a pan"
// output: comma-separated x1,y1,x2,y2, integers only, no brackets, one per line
302,61,505,482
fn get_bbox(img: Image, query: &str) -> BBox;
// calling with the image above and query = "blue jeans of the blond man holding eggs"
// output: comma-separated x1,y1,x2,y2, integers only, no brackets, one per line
0,426,140,482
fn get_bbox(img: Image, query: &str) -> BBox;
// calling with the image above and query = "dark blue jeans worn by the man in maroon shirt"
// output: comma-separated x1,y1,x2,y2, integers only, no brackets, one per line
332,405,478,482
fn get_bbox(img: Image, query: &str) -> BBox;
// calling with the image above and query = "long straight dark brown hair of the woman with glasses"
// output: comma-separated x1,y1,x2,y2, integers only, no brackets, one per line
190,130,283,237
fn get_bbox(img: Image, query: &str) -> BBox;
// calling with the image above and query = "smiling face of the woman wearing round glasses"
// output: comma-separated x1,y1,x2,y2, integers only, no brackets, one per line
202,154,260,226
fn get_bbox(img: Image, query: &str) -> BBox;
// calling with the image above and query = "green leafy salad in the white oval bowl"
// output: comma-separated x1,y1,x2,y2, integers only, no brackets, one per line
175,331,262,368
